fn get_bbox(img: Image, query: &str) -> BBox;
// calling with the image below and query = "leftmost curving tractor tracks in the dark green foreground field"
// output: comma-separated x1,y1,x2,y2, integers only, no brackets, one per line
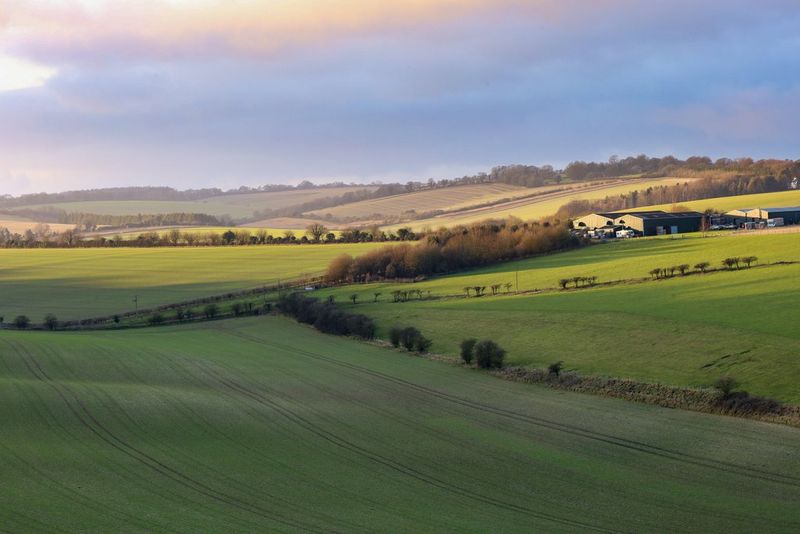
3,344,323,532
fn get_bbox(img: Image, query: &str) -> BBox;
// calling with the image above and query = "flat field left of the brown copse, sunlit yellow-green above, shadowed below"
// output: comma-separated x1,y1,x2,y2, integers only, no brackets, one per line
0,244,390,322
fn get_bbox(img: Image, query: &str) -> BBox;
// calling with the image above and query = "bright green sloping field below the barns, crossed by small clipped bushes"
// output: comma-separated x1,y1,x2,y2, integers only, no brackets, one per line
322,234,800,403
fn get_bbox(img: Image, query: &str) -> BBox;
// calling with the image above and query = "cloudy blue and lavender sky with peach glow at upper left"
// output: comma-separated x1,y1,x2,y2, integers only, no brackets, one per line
0,0,800,195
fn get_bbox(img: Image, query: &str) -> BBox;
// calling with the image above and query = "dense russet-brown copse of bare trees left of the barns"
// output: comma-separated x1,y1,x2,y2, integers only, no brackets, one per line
326,220,585,283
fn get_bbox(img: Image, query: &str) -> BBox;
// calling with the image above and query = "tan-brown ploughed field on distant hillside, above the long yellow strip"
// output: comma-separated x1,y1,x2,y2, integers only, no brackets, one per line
308,184,536,217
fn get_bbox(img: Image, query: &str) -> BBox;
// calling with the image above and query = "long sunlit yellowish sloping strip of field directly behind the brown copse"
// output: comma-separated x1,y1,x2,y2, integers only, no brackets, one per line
387,178,691,229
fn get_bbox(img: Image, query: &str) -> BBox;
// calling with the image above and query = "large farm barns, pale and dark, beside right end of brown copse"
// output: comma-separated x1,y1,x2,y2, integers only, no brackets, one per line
573,211,705,235
